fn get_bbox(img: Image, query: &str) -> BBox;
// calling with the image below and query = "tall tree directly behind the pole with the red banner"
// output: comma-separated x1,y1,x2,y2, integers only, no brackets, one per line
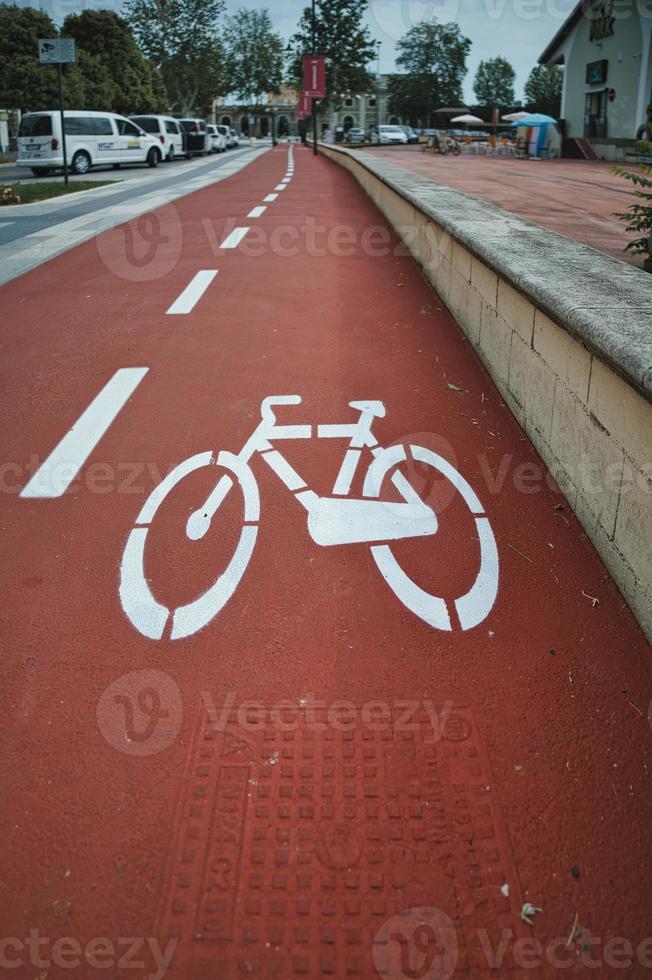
289,0,376,108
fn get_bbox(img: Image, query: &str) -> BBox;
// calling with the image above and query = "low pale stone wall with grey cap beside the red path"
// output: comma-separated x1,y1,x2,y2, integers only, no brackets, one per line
320,145,652,640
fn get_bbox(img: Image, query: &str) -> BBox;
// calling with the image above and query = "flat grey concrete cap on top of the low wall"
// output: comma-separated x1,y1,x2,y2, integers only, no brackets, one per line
322,146,652,401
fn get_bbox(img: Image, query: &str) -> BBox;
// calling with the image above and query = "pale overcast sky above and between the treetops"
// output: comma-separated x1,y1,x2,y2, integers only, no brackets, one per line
29,0,576,102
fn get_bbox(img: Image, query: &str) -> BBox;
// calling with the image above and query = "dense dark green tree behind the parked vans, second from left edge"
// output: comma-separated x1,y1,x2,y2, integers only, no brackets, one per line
61,10,167,115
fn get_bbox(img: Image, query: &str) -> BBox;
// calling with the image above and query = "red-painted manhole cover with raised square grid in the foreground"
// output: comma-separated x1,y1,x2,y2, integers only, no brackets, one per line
157,708,538,980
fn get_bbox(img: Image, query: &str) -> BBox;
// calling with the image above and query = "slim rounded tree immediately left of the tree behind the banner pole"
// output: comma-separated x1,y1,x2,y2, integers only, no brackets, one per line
224,7,284,107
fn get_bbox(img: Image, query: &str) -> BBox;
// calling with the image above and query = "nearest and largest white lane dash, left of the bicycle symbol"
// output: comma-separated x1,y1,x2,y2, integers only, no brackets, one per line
20,368,149,499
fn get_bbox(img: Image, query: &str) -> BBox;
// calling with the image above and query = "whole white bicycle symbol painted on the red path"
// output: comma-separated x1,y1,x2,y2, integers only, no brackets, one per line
120,395,498,640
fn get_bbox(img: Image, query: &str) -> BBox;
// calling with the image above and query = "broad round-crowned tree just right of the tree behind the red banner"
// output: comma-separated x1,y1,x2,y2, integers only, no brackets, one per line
388,19,471,126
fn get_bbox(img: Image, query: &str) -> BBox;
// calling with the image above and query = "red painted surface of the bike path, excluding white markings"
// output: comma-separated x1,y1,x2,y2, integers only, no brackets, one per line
0,147,652,980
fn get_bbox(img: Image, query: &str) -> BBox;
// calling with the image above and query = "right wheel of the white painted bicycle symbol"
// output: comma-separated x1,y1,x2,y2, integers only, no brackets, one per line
363,446,499,632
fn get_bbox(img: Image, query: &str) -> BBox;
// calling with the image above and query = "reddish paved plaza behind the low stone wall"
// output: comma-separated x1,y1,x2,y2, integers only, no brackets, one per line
362,146,643,268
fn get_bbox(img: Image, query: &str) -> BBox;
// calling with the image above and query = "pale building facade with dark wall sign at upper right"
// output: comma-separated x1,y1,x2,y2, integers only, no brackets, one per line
539,0,652,145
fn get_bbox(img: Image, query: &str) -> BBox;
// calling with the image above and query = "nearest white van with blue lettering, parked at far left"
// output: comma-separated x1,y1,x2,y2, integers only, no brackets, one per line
16,109,163,177
